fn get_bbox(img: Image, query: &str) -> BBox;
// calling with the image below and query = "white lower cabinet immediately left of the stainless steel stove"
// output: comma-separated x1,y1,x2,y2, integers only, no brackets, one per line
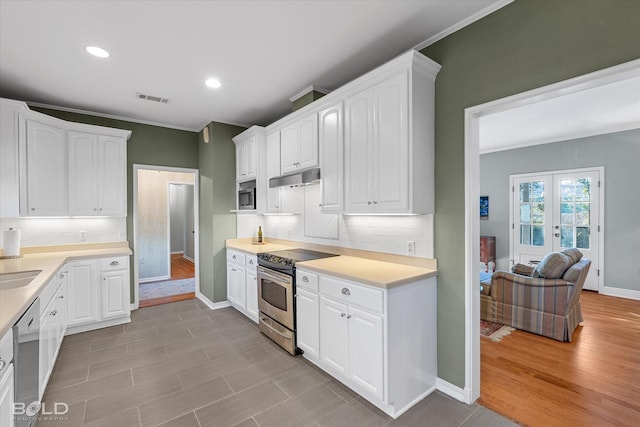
227,249,259,323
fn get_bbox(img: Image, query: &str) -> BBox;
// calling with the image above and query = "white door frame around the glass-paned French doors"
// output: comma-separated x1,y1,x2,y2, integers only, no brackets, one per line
509,166,605,292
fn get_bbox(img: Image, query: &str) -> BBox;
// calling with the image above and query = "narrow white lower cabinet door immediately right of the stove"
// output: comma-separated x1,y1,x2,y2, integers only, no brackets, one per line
296,287,320,360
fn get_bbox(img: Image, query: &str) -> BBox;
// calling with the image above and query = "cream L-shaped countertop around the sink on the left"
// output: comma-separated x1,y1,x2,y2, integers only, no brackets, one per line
0,242,132,336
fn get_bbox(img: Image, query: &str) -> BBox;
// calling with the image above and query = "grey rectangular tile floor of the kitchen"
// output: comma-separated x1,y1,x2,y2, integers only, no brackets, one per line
38,300,515,427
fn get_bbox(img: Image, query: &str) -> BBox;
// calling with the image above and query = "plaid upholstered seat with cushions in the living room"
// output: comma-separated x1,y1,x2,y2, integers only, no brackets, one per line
480,248,591,342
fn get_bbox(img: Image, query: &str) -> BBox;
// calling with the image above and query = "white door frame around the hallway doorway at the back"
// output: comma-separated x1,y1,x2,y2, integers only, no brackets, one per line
132,164,200,310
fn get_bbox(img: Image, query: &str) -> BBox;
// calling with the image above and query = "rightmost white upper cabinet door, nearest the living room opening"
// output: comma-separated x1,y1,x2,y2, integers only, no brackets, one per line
372,71,410,212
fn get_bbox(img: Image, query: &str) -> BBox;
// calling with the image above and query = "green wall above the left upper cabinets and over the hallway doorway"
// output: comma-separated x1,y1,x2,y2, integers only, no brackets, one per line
29,106,198,302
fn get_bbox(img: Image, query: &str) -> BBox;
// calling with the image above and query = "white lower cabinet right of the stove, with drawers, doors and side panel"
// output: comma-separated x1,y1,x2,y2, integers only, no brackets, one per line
296,267,437,418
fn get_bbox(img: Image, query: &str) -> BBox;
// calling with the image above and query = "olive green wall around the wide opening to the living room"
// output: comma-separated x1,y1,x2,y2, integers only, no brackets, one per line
421,0,640,387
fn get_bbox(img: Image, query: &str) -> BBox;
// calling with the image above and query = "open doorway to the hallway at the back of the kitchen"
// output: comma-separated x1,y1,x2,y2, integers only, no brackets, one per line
133,165,199,308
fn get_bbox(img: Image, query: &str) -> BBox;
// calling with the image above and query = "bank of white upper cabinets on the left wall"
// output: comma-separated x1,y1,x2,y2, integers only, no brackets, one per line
0,99,131,218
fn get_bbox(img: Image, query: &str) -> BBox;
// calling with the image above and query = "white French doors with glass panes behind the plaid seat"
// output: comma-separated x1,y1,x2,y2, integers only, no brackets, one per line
510,169,603,291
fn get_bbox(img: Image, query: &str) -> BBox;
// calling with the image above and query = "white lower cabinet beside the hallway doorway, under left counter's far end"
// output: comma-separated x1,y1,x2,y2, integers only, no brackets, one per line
67,256,131,333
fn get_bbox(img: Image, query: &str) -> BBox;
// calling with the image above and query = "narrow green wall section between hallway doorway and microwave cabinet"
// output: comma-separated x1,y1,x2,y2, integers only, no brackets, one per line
198,122,245,303
